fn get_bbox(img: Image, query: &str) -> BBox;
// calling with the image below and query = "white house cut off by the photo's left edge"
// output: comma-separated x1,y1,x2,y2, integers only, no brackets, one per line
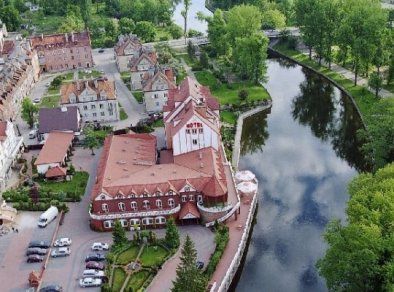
0,121,23,191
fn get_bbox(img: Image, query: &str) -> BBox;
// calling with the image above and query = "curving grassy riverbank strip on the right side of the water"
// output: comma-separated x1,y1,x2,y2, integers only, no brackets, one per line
271,43,394,169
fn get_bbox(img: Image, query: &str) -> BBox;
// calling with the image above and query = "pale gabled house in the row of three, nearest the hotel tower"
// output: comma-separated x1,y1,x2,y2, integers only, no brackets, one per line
143,68,176,112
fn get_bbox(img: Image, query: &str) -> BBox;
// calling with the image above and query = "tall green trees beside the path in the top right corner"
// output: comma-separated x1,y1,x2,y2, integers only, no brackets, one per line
295,0,393,85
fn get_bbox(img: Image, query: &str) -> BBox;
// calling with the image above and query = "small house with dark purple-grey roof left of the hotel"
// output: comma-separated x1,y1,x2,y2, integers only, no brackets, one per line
38,106,81,141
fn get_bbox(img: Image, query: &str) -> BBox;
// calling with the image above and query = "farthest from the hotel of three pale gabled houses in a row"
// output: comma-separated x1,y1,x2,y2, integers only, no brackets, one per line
114,34,142,72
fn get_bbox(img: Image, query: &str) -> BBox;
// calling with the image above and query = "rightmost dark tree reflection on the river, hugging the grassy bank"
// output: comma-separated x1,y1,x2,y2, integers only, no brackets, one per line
331,94,372,172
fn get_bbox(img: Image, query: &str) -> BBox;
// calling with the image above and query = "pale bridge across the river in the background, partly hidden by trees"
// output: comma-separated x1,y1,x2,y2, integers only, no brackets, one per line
146,27,301,49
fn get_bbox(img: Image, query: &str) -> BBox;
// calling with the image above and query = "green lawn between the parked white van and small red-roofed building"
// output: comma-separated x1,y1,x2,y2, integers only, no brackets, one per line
38,171,89,196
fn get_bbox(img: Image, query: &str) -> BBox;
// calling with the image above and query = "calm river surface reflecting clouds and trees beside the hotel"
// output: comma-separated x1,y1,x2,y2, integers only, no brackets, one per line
236,59,368,292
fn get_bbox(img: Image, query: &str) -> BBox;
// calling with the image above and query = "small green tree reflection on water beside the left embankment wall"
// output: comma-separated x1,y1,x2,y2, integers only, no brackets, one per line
241,109,271,155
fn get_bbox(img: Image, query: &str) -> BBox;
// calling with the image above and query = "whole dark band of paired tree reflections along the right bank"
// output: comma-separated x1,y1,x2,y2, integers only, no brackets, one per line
292,69,370,171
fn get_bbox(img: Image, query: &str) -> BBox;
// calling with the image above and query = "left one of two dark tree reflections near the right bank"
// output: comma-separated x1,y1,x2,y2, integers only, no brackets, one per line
292,70,335,140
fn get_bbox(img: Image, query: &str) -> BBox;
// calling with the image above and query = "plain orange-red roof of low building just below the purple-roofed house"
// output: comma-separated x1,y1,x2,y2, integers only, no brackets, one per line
34,131,74,165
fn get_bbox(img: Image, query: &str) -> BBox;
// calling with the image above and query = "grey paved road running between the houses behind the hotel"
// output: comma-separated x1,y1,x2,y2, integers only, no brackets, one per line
93,49,147,129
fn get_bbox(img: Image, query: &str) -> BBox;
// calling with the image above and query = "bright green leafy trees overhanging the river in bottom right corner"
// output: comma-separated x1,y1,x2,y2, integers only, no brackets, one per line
317,164,394,291
